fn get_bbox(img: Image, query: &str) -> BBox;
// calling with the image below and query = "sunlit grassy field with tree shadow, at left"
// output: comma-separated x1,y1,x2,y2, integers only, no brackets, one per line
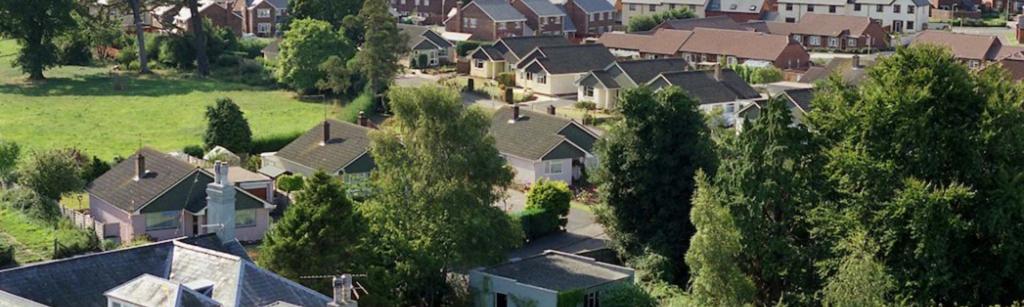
0,40,342,160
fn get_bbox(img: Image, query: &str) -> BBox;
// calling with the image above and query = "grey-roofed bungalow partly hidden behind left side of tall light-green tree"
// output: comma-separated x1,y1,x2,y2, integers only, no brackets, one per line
260,118,376,181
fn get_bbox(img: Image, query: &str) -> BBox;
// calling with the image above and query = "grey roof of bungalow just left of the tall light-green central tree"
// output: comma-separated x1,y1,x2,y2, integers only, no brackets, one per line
276,120,370,173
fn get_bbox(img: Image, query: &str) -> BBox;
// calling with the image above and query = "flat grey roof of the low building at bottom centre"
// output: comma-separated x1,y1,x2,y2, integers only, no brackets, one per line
483,251,633,292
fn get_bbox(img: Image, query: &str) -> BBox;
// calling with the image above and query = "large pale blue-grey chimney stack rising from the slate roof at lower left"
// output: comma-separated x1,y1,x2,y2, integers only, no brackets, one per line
206,161,236,244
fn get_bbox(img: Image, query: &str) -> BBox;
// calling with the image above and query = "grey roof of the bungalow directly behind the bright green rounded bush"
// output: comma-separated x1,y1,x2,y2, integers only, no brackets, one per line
490,106,597,161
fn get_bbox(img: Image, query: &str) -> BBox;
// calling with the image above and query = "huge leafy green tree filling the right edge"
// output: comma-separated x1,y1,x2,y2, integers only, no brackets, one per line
809,46,1024,305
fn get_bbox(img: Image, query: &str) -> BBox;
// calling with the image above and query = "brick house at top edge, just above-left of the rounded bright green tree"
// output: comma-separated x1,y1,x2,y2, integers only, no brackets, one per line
231,0,288,37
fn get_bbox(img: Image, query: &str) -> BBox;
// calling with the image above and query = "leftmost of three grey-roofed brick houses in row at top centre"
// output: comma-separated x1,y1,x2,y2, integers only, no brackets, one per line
444,0,527,41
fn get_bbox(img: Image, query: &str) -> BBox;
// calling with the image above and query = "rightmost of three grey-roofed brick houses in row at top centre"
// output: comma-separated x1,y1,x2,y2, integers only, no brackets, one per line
564,0,620,37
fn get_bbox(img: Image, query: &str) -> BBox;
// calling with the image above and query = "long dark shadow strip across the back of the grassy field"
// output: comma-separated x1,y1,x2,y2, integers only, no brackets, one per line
0,74,271,97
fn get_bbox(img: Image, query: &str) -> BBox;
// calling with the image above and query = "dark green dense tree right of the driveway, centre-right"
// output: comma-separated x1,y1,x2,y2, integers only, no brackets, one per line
596,87,717,284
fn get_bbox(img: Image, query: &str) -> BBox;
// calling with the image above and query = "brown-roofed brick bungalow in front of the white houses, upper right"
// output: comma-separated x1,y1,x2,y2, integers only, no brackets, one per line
765,13,890,51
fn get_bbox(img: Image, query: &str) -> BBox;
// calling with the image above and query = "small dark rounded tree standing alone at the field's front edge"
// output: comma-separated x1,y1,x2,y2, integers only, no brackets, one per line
203,98,253,154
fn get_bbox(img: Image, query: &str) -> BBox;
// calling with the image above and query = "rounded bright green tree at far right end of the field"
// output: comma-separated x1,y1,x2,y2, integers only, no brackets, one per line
275,19,355,91
